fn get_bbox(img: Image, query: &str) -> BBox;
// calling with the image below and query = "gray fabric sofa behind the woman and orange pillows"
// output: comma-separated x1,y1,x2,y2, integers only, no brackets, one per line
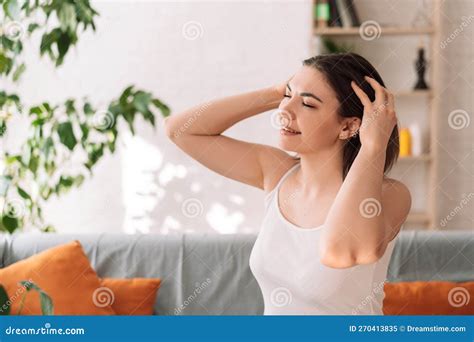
0,231,474,315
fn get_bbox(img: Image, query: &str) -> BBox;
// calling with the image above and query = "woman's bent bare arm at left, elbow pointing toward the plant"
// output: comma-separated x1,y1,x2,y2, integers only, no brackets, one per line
165,84,294,190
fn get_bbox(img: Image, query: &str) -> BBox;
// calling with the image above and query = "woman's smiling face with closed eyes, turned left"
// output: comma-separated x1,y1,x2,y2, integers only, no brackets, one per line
278,66,342,154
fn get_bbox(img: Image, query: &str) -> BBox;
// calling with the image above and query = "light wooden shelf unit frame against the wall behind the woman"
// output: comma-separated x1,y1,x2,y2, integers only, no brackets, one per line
313,0,441,229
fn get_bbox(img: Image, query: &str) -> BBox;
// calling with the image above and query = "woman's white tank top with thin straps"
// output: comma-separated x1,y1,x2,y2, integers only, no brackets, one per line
249,163,398,315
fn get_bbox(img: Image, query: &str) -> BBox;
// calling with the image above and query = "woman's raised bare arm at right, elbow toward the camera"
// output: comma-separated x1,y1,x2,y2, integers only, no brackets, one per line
320,77,411,268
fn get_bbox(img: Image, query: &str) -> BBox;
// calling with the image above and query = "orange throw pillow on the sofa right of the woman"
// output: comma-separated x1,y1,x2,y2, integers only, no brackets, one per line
383,281,474,315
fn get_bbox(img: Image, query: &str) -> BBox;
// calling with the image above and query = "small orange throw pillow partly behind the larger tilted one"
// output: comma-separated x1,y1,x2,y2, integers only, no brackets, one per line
101,278,161,315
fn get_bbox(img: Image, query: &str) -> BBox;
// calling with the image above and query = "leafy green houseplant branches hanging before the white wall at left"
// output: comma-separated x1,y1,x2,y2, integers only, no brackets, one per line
0,0,170,233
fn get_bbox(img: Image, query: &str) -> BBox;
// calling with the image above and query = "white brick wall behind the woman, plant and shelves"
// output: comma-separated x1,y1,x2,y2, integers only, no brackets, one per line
3,0,473,233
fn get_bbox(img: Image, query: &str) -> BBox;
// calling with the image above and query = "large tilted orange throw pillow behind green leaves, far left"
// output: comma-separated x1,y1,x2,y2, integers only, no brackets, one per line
0,240,115,315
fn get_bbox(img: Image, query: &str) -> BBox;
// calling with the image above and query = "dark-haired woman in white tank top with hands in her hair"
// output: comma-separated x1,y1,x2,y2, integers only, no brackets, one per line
165,53,411,315
